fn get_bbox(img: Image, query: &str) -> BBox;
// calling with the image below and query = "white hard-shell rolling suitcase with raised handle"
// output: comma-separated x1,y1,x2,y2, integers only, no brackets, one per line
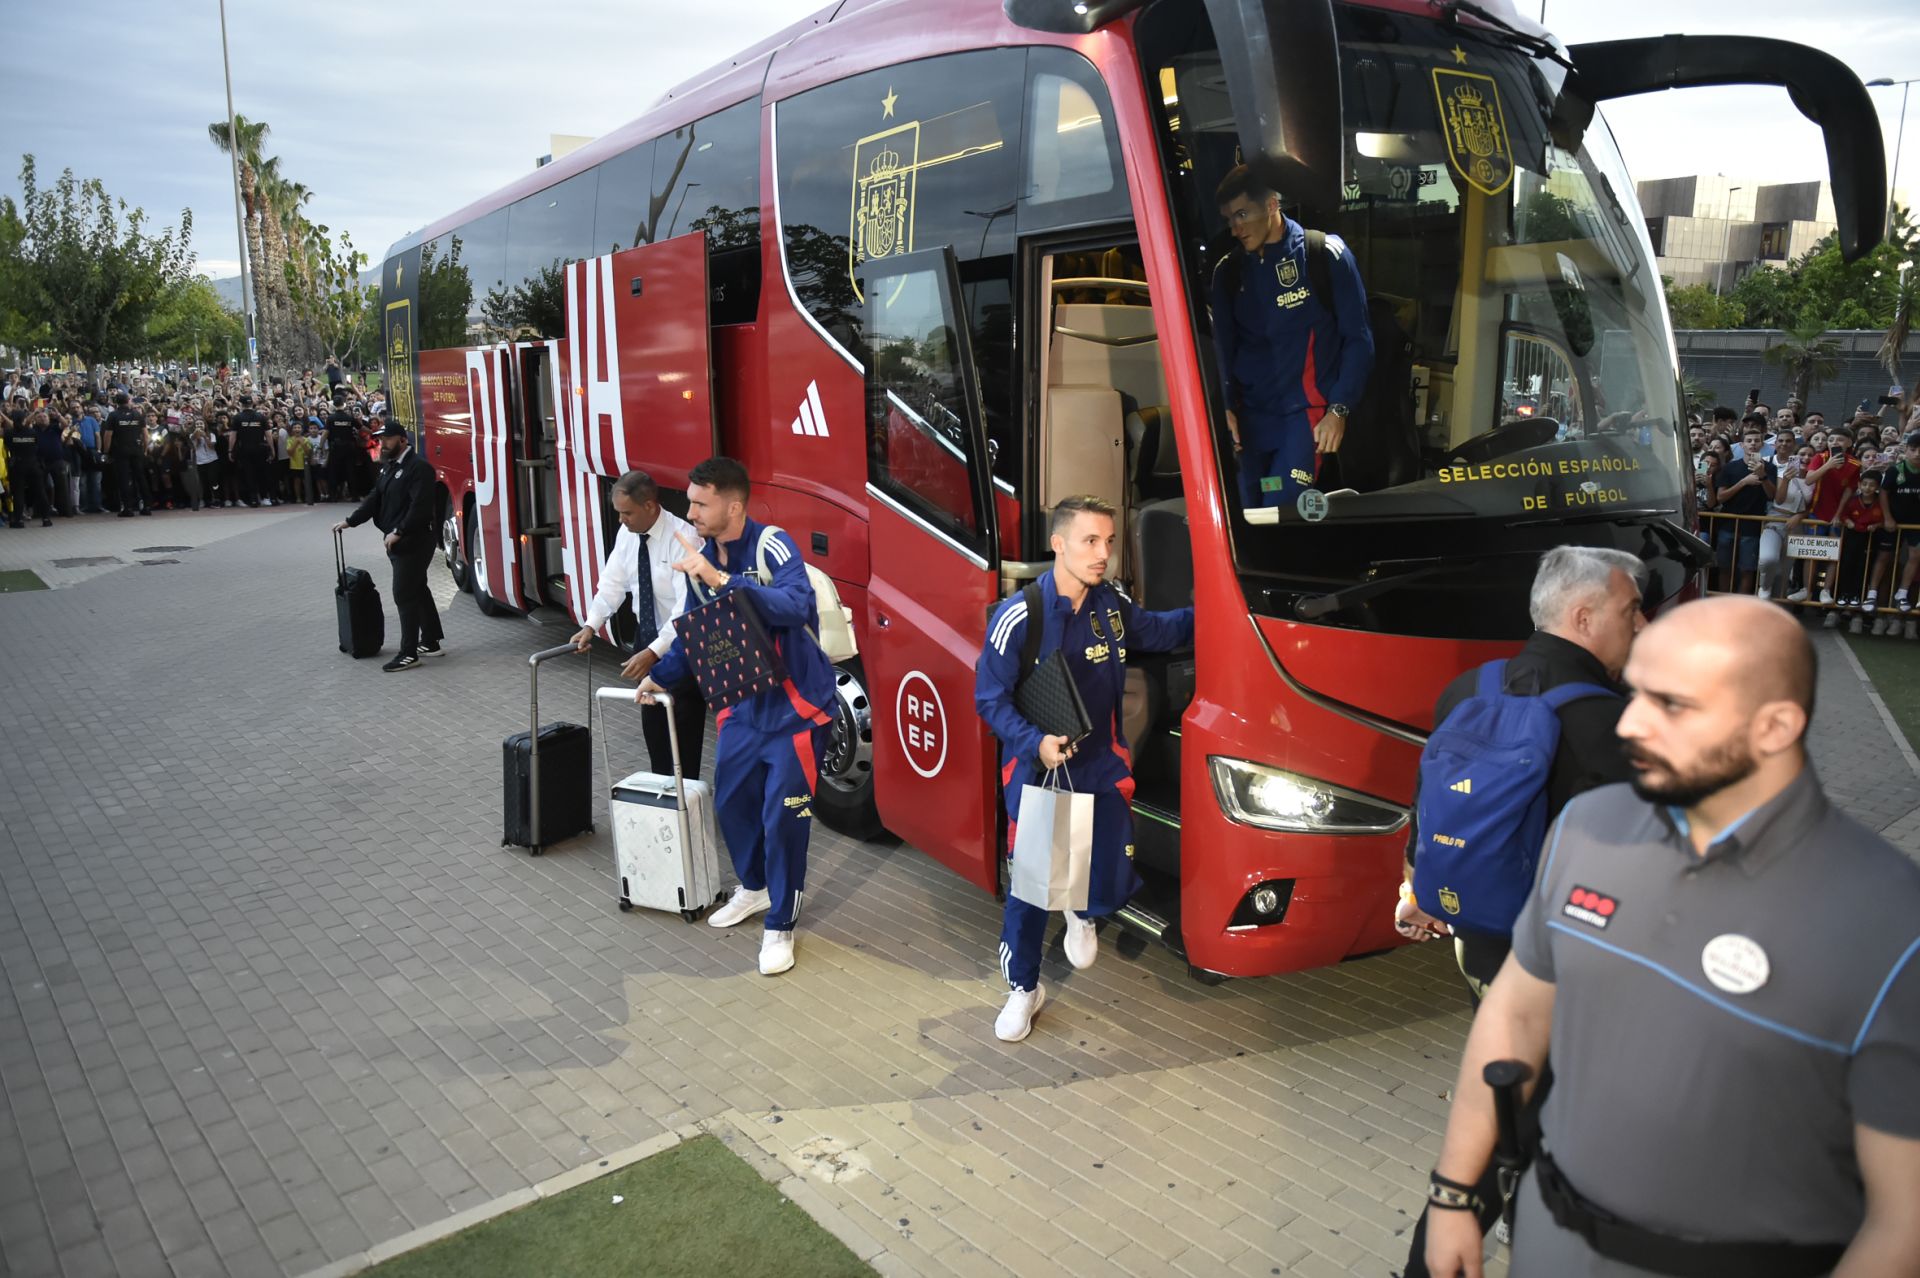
595,687,722,923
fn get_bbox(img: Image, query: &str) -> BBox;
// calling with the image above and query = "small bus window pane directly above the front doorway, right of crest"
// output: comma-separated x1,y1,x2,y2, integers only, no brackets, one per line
1020,48,1131,230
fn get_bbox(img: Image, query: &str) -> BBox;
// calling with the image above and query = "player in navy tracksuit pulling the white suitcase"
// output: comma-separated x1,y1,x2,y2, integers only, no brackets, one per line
639,457,833,977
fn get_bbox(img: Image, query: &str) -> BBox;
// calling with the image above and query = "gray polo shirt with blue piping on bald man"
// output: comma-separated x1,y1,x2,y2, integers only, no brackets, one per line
1513,769,1920,1261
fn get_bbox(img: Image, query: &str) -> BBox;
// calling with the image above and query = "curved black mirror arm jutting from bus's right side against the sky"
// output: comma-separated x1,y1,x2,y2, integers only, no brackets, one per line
1574,34,1887,261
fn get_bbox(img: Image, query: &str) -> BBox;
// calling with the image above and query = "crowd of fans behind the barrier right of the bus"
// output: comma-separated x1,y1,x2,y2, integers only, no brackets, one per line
1688,383,1920,639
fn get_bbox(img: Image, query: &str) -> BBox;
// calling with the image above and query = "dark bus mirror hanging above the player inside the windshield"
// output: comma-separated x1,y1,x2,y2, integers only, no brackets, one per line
1206,0,1346,219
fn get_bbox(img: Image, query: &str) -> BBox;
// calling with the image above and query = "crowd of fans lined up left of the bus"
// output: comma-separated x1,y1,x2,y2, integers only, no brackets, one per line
0,361,386,528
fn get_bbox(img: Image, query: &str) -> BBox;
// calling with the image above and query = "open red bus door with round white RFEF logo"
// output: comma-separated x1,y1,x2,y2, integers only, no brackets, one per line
856,248,1000,892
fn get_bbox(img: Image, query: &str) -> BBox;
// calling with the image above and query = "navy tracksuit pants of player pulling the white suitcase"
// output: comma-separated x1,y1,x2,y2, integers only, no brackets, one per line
714,714,828,933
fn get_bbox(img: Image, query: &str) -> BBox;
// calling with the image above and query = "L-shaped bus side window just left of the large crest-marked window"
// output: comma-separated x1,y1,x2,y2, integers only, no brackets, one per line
649,98,760,324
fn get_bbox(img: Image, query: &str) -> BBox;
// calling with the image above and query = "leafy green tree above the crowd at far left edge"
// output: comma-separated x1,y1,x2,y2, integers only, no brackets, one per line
0,155,194,368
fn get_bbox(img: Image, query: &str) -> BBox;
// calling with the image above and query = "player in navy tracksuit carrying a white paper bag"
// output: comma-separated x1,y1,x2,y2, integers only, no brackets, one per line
973,497,1194,1042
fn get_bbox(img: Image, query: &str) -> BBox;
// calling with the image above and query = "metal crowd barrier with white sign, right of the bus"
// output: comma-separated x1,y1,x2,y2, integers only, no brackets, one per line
1699,510,1920,633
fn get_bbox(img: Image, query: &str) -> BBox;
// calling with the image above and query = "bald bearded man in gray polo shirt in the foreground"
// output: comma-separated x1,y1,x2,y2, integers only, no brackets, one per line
1427,597,1920,1278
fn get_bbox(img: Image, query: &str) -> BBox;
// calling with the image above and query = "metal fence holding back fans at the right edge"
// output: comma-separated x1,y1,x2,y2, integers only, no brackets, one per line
1699,510,1920,639
